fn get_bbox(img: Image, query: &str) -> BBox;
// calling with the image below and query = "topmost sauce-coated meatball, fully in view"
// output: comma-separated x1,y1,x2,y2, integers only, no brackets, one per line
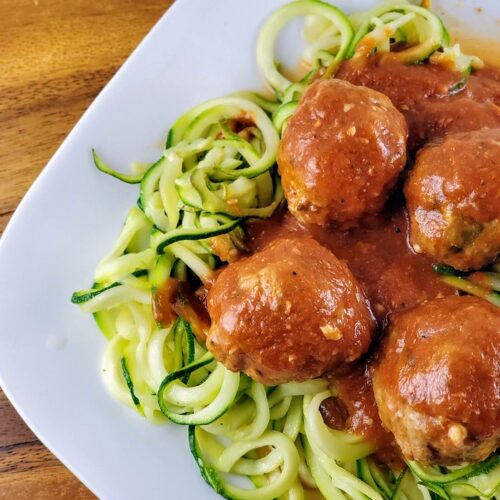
277,80,408,225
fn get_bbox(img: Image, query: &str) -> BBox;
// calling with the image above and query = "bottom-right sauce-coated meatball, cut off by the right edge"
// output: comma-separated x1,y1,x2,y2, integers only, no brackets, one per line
372,296,500,465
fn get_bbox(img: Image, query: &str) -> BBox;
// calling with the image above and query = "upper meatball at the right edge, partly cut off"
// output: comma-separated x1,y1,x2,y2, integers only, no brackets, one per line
405,128,500,271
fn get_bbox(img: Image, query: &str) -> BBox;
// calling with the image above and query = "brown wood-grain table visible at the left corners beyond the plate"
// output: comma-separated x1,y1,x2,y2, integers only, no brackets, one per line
0,0,173,500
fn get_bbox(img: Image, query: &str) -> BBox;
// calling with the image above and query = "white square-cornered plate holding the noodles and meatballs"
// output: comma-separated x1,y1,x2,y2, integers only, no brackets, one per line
0,0,498,500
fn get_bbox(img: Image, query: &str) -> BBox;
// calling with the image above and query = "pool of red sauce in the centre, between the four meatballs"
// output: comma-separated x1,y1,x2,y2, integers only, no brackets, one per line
248,204,455,326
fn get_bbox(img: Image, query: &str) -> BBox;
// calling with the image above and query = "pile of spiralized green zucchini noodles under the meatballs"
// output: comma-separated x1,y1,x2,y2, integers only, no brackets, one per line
72,0,500,500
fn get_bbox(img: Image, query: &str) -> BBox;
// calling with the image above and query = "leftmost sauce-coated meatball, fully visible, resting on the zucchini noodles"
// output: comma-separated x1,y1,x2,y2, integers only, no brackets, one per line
207,238,374,385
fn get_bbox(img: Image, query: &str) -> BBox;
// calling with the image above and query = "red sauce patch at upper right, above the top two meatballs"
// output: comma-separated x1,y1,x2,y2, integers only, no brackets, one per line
336,55,500,151
